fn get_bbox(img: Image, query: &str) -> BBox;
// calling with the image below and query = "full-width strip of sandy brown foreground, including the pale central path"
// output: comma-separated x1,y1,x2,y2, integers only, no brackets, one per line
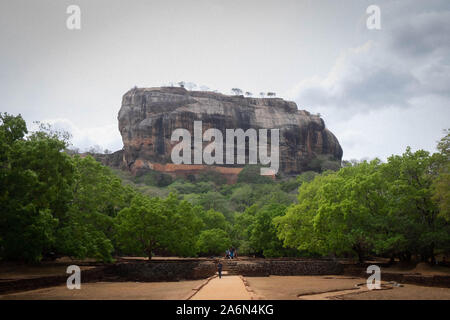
0,276,450,300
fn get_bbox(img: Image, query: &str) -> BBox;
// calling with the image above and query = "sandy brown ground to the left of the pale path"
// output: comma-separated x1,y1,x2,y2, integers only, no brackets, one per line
0,280,204,300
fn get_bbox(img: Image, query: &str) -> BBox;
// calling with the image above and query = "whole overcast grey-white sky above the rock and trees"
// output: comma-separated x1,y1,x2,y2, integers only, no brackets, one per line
0,0,450,159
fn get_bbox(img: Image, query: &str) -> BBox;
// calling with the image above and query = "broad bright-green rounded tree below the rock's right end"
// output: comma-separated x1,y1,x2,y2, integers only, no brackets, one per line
275,160,383,261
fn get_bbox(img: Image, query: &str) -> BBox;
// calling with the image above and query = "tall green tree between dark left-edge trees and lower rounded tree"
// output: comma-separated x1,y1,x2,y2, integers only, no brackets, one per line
56,155,134,261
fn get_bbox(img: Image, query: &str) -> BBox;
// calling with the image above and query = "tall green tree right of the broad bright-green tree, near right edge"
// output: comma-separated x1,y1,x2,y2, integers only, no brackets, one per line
385,148,450,262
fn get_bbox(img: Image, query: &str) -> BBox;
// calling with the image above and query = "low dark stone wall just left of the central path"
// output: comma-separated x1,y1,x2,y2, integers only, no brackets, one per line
107,260,216,282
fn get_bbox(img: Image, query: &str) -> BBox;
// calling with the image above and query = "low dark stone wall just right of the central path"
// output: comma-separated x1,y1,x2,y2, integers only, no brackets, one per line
236,260,343,277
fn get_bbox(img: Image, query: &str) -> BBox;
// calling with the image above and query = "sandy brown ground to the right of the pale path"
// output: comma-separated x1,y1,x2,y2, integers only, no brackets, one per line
246,276,450,300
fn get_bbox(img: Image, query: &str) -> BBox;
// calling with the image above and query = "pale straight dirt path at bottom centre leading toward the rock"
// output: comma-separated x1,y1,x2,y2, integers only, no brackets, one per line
190,276,251,300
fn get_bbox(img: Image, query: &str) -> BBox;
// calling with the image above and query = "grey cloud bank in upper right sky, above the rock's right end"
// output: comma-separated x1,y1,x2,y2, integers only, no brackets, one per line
293,5,450,113
